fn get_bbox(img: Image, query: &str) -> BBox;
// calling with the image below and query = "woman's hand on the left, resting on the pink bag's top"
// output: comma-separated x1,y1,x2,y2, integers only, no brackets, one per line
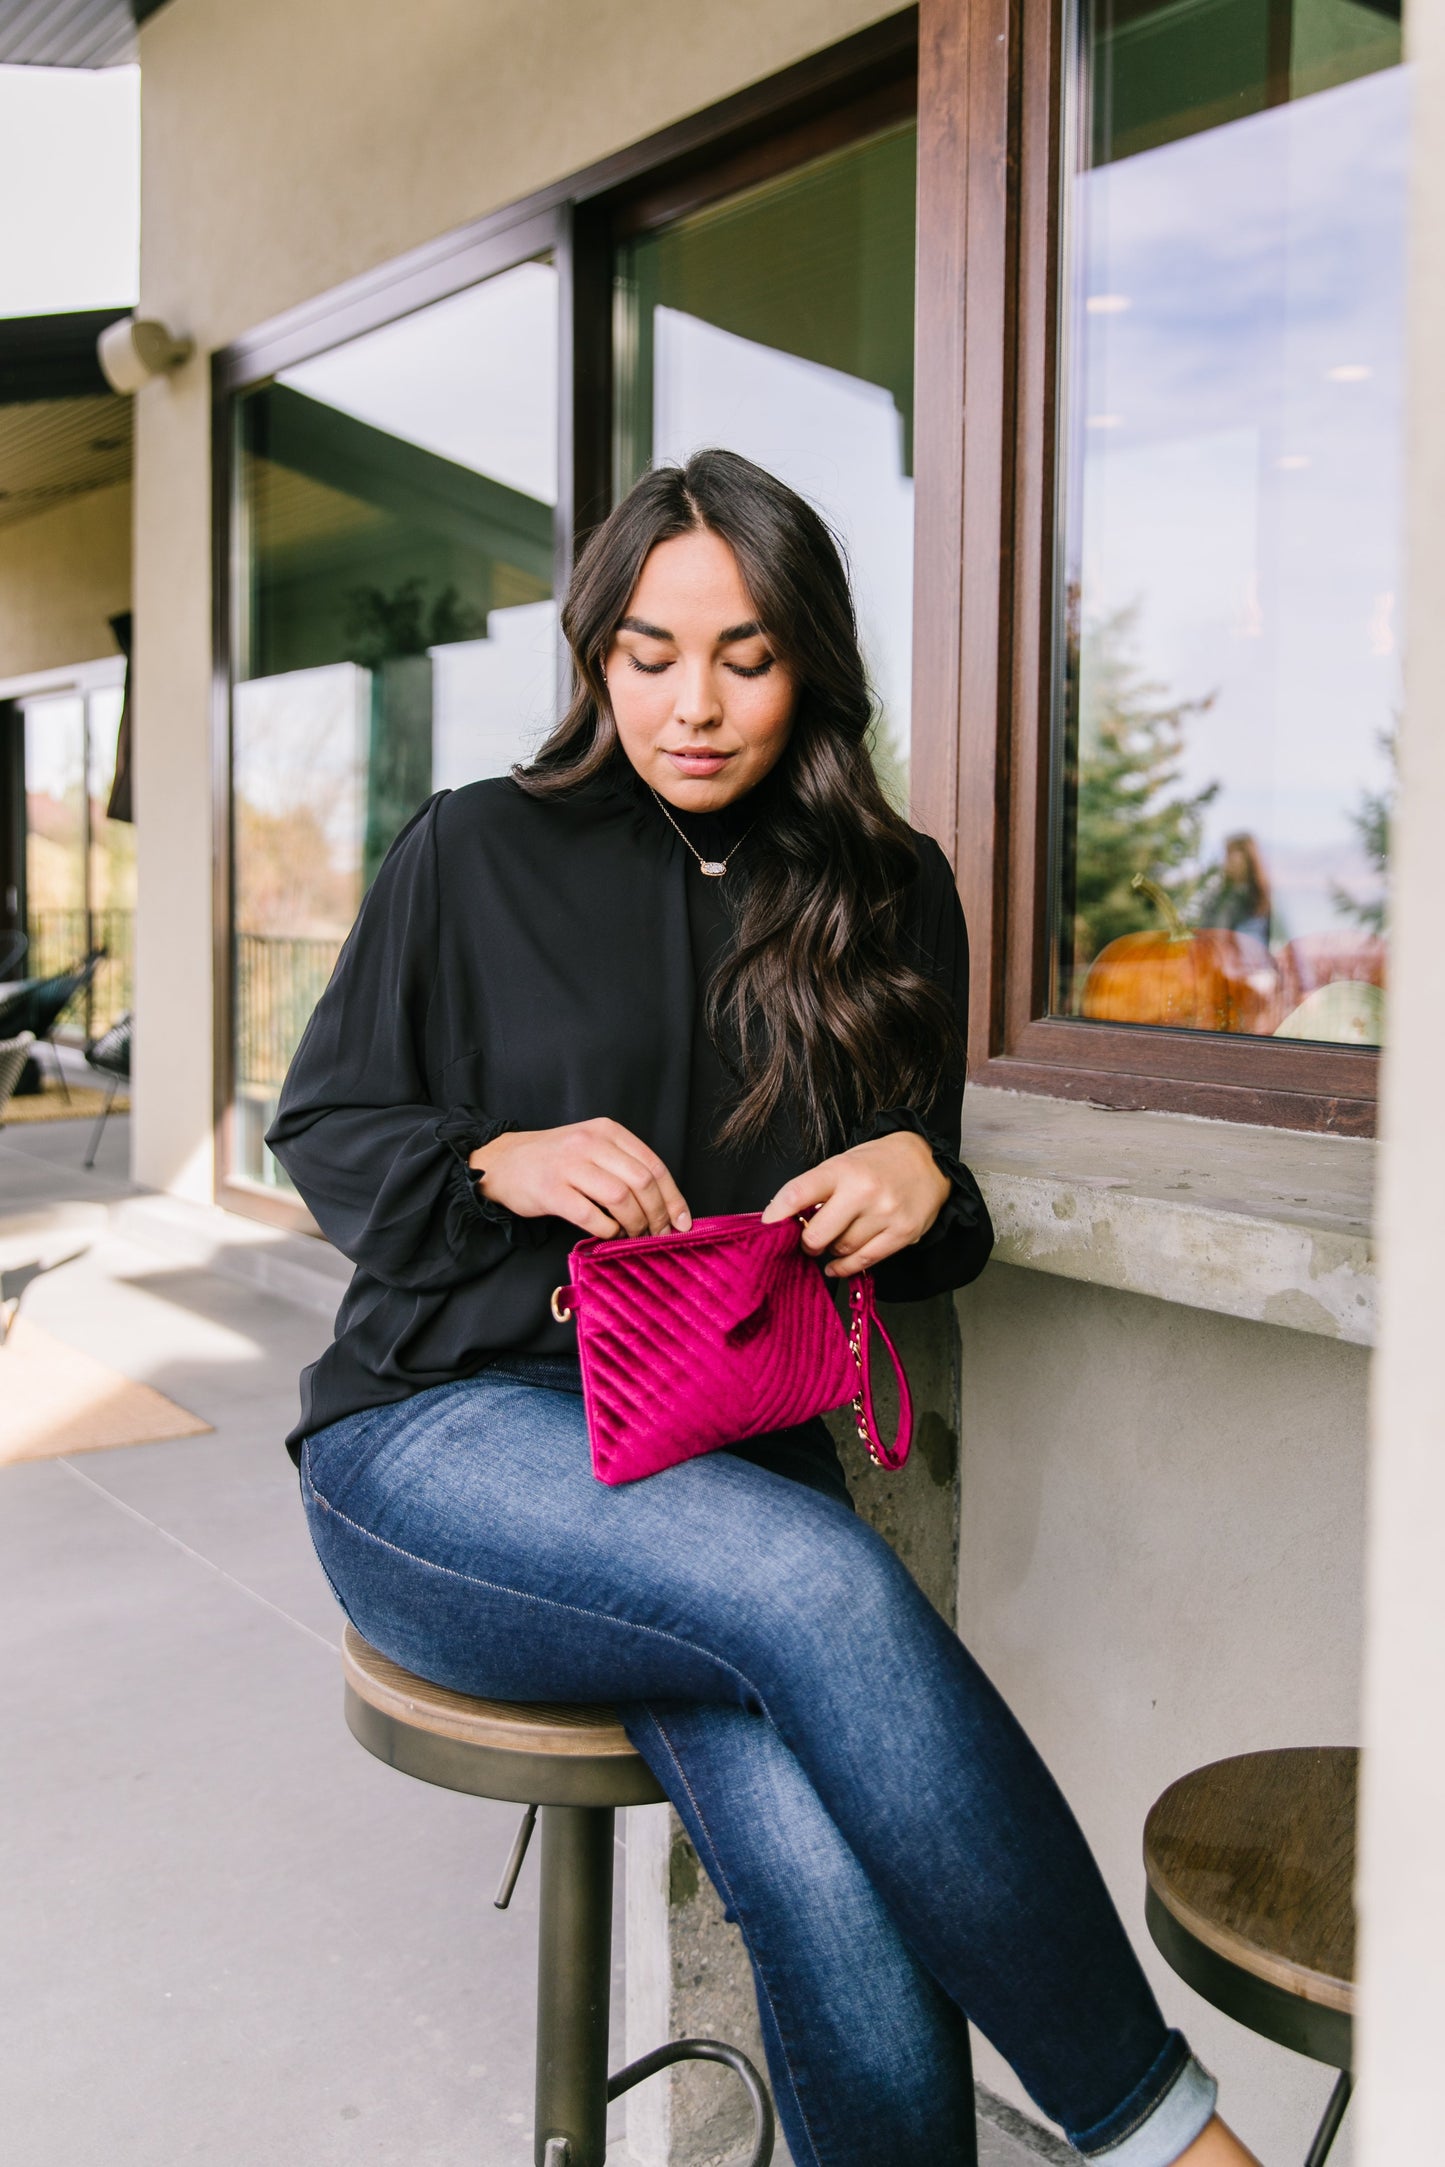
468,1118,693,1237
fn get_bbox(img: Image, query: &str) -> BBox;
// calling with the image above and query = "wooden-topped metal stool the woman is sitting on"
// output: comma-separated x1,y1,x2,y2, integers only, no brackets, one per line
342,1625,773,2167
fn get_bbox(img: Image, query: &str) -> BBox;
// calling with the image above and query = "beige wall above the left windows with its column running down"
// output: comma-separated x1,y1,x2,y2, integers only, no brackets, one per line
134,0,893,1198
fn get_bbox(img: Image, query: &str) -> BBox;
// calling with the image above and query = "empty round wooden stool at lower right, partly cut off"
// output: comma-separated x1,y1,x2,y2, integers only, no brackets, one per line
1144,1747,1358,2167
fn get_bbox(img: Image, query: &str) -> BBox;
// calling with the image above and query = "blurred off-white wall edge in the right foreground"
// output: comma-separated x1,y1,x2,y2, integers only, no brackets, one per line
1358,4,1445,2167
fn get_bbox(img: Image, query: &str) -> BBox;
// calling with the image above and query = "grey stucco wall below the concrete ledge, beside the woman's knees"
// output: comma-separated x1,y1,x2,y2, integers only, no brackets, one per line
958,1266,1369,2167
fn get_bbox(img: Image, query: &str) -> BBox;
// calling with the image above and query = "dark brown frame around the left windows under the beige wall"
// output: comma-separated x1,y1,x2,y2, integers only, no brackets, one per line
210,9,919,1233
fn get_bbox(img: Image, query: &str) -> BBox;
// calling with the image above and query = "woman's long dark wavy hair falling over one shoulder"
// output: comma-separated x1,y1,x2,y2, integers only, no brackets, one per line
513,451,964,1153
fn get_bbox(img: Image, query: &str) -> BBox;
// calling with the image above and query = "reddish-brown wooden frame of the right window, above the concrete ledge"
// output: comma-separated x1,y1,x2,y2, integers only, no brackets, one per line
914,0,1380,1136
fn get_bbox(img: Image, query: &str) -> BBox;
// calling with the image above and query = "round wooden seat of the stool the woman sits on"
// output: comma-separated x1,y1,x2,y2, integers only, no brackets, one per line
342,1625,663,1807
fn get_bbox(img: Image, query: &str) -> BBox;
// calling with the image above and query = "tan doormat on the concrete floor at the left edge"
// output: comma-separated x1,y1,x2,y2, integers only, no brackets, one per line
0,1318,210,1467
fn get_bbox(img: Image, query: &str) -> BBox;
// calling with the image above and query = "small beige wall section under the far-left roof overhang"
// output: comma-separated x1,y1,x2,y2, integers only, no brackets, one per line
0,481,130,678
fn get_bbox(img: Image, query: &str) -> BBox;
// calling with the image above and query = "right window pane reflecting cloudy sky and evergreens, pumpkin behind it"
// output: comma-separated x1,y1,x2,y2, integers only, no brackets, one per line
1051,0,1408,1044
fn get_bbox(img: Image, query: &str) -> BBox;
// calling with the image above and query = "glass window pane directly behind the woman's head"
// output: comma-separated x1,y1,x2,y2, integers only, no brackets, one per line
617,121,916,806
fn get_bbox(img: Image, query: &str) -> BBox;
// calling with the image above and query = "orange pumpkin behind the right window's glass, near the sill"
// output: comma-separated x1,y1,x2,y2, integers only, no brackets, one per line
1081,873,1280,1034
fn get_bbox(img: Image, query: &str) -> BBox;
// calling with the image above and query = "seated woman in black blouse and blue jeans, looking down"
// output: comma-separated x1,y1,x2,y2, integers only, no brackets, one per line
271,451,1248,2167
